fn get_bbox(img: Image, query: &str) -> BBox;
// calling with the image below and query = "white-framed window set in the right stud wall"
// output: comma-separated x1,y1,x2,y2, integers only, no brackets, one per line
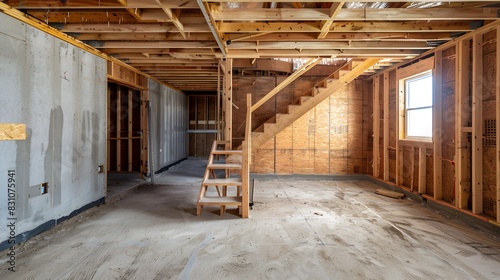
404,71,433,141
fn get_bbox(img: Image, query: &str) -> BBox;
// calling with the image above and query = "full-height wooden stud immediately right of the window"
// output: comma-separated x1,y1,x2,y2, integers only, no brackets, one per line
432,51,443,200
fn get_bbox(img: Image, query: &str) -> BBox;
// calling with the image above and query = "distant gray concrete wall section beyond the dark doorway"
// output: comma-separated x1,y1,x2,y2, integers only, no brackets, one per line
149,80,188,172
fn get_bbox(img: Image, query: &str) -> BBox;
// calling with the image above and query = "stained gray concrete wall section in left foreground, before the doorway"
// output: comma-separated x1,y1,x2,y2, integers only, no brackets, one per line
0,14,107,249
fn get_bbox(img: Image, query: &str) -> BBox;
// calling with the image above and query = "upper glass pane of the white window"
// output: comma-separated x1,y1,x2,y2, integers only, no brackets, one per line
406,75,432,108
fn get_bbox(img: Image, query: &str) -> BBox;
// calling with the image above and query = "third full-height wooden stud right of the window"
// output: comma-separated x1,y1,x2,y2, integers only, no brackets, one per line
472,33,483,214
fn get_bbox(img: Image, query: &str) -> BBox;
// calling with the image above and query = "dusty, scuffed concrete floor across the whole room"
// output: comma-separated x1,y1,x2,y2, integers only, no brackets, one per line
0,160,500,279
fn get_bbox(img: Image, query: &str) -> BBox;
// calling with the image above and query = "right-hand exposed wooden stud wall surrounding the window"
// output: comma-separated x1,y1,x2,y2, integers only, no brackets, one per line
372,22,500,225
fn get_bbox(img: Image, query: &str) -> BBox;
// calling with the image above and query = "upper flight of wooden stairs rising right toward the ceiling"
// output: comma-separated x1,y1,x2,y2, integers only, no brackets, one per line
251,59,379,149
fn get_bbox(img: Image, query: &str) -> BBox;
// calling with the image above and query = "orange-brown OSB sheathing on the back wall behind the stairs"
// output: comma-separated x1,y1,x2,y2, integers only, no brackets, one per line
233,74,371,174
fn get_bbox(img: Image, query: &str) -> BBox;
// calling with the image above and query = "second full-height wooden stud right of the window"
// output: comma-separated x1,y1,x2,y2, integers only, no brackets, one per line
455,40,472,209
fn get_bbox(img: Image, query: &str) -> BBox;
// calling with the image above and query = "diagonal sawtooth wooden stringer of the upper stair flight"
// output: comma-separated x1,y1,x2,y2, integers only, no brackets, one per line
252,58,380,150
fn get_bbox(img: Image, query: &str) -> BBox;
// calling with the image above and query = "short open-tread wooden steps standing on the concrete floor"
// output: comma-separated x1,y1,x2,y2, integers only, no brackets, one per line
196,141,248,217
